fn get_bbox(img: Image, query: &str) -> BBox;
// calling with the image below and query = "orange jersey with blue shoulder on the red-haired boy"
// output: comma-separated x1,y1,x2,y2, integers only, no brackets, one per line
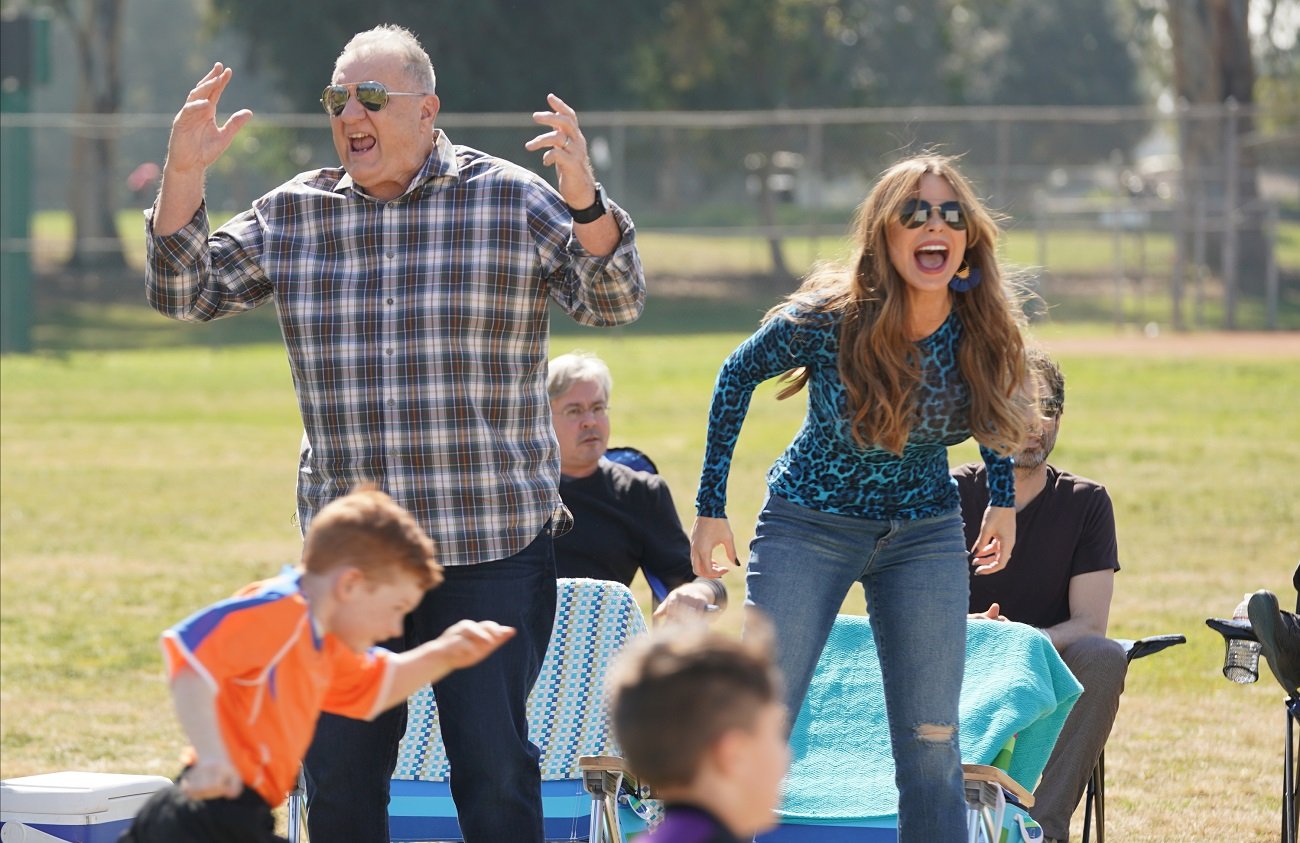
163,570,391,807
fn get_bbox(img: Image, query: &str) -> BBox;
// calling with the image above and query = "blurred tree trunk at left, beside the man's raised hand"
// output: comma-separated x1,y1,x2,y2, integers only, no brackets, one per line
56,0,126,269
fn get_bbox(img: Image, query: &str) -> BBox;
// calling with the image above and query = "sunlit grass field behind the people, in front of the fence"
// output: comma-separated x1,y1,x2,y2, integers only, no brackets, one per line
0,333,1300,843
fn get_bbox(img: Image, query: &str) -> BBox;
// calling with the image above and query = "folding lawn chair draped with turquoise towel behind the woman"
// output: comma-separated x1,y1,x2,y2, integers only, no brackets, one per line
759,615,1082,843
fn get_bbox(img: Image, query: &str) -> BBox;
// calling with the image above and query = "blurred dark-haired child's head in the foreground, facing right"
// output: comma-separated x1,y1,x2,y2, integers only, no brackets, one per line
610,619,789,843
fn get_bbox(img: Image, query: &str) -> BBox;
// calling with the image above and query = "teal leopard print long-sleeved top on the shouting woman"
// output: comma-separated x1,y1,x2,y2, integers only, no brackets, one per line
696,308,1015,520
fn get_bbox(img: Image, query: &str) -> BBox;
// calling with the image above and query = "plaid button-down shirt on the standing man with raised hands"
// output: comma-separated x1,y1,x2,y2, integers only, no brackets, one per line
146,131,645,565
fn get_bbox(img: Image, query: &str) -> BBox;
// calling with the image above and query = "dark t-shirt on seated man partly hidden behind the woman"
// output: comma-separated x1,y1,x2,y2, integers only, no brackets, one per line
953,463,1119,628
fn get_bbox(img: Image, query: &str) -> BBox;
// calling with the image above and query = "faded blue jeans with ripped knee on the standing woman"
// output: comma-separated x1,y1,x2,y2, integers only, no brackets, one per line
745,494,970,843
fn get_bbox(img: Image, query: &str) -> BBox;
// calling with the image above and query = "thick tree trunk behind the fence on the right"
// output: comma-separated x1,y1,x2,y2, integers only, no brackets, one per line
1166,0,1268,303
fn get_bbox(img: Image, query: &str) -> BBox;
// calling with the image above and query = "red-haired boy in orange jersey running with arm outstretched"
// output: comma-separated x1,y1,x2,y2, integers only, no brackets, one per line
121,487,515,843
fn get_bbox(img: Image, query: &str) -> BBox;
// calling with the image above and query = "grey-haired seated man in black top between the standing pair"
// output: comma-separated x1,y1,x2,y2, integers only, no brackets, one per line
546,353,727,618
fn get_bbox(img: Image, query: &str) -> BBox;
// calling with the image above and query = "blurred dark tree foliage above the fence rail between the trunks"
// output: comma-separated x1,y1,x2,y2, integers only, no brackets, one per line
213,0,1154,111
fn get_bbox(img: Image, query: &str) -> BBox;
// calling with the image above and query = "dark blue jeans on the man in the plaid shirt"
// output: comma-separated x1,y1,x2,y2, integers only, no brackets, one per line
304,527,555,843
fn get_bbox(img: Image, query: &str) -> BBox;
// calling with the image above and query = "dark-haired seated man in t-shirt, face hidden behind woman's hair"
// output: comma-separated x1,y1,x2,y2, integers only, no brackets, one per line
953,349,1127,840
